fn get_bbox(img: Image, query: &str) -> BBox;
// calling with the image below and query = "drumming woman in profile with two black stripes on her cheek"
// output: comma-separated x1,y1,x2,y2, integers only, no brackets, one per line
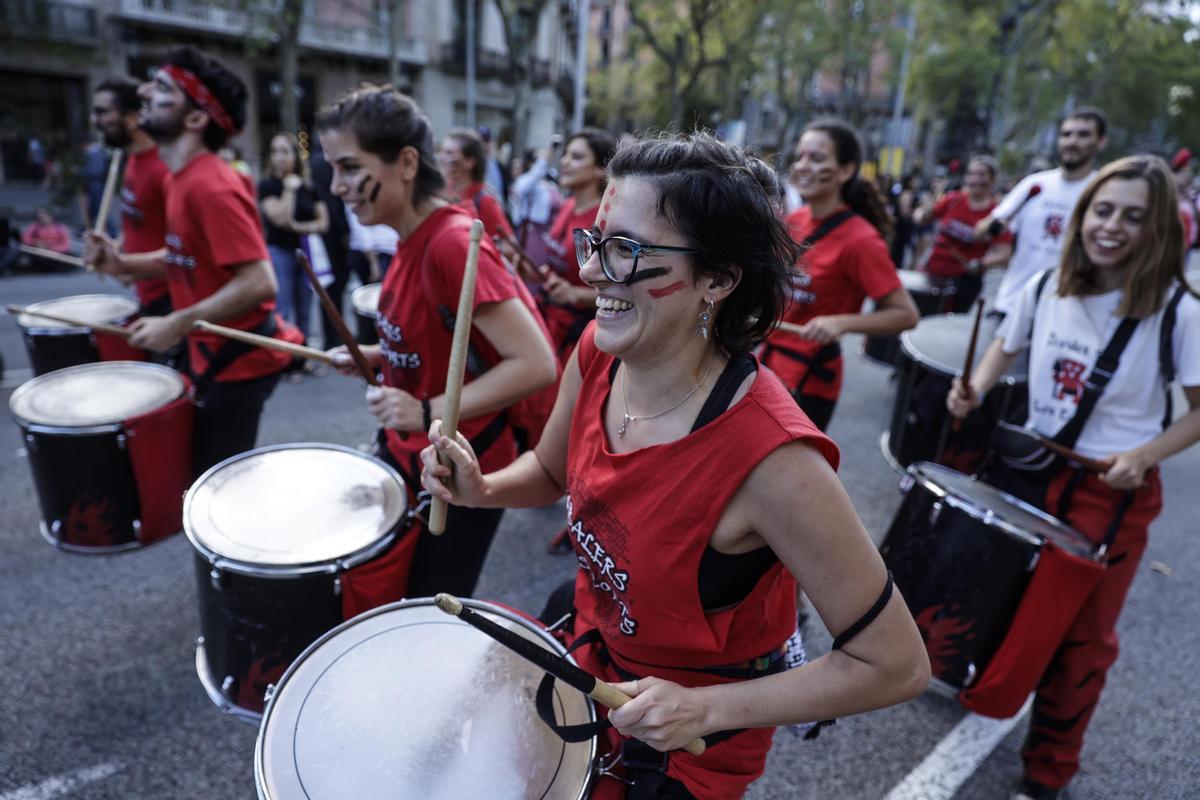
317,86,558,610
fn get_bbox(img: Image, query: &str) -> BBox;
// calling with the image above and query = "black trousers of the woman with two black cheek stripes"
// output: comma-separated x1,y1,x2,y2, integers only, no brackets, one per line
376,439,504,597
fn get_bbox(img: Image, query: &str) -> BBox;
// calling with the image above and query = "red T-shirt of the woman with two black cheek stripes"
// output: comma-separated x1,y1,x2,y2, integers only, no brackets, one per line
376,205,521,479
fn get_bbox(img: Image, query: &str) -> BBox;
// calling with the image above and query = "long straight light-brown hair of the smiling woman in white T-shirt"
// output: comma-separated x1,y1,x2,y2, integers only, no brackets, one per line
1058,155,1190,319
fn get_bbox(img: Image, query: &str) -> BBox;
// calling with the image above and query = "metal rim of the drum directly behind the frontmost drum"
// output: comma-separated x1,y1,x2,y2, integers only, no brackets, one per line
182,441,408,578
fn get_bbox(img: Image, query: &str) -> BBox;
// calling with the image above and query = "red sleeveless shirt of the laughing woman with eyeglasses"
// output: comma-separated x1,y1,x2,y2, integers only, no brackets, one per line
566,324,838,800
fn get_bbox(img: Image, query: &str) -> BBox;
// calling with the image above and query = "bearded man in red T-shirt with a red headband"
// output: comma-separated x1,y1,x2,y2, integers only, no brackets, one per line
98,48,302,474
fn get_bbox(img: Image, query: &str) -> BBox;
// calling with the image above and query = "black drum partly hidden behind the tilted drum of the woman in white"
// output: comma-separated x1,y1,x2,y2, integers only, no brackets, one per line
881,314,1028,474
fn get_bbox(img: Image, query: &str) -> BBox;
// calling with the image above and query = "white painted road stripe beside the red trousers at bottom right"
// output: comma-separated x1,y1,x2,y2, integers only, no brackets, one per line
883,697,1033,800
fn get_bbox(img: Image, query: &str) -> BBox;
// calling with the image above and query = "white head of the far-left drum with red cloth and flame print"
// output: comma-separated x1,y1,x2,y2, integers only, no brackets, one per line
8,361,184,428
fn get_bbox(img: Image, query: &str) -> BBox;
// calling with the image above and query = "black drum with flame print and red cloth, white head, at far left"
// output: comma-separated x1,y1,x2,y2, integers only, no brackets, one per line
8,361,193,553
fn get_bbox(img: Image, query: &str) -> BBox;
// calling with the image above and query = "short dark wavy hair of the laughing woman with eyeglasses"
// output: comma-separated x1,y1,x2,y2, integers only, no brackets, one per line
608,132,798,355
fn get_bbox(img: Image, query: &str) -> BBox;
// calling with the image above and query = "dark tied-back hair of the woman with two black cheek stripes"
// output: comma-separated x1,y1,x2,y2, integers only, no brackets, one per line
317,84,445,201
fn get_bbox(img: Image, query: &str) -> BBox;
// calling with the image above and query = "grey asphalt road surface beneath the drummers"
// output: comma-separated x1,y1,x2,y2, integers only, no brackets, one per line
0,275,1200,800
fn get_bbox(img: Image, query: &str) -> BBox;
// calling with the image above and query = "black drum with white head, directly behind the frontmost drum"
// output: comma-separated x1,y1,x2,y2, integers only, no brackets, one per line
184,444,407,722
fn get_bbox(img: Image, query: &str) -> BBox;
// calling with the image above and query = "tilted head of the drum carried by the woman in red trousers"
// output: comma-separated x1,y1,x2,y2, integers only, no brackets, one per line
908,462,1096,559
